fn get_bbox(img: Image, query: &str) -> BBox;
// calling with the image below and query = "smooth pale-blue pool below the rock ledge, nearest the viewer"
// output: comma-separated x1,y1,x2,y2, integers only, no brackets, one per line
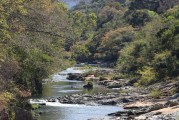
38,105,120,120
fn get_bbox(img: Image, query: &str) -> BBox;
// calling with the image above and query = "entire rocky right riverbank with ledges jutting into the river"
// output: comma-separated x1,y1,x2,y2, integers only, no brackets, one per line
62,71,179,120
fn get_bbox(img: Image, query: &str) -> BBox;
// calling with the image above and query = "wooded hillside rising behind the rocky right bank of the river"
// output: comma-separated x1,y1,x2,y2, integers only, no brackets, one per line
70,0,179,85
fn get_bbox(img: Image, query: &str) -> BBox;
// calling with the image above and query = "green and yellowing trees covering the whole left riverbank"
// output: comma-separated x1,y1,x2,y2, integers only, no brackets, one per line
0,0,76,116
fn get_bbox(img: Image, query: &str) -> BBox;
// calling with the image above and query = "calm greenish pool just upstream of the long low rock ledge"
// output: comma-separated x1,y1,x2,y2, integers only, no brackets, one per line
40,81,114,98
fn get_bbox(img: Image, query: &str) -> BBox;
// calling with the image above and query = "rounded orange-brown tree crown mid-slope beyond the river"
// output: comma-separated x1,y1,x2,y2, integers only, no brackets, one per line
98,26,133,62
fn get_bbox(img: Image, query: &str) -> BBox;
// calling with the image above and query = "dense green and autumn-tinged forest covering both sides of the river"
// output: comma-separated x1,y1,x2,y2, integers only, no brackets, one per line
0,0,179,120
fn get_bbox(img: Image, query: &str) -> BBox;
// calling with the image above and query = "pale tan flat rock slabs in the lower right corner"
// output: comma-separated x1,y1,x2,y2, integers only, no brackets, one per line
109,99,179,120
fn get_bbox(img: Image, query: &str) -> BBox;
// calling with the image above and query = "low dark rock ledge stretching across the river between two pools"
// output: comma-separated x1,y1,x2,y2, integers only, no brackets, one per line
48,88,149,105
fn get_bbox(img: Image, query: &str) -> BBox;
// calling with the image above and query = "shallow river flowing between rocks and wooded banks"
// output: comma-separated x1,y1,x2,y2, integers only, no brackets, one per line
33,67,122,120
